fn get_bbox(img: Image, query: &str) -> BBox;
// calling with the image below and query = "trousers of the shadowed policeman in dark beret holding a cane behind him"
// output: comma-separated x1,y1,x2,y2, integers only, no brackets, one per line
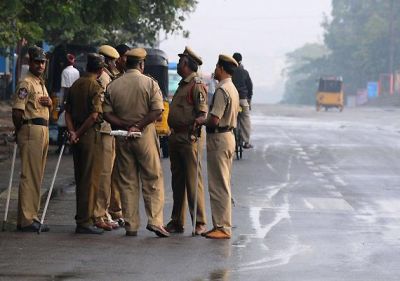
72,128,103,226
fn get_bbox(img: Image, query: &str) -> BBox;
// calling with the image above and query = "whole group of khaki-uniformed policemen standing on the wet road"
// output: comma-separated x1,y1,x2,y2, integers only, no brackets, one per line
12,45,240,239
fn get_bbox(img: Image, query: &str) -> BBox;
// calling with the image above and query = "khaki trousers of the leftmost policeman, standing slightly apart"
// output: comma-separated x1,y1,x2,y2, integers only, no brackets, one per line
17,125,49,227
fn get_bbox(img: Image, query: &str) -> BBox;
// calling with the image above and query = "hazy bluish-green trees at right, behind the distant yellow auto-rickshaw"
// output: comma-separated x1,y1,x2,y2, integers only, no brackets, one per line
284,0,400,104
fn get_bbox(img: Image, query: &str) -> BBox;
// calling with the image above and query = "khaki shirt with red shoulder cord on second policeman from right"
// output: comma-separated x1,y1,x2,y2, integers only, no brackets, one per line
168,72,208,128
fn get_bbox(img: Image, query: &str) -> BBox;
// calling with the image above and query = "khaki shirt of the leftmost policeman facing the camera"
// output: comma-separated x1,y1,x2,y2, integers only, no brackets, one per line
12,71,49,120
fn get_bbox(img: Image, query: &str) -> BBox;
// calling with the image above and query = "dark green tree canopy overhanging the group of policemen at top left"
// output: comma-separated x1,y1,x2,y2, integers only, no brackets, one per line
0,0,197,48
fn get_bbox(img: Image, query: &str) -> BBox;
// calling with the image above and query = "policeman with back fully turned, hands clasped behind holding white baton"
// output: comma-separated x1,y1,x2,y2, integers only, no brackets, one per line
103,48,169,237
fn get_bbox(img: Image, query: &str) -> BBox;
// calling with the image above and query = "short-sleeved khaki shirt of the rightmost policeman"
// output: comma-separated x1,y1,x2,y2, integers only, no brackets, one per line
210,78,239,128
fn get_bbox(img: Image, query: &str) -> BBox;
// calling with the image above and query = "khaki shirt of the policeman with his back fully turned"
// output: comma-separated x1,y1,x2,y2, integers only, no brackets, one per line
103,69,164,124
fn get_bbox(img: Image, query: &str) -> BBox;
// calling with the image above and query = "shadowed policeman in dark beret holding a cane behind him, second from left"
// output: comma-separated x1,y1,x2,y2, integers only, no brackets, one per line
65,53,104,234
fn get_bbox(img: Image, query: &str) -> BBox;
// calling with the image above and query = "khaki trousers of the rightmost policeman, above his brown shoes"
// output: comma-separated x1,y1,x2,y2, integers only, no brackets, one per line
207,132,235,234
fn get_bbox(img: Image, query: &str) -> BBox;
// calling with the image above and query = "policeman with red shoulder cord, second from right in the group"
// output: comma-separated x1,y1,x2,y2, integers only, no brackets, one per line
166,47,208,235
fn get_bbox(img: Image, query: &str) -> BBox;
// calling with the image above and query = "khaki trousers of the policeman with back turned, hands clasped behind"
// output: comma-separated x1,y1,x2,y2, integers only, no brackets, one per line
113,124,164,231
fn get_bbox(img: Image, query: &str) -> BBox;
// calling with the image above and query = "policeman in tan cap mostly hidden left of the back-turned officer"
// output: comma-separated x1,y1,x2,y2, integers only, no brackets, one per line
94,45,123,231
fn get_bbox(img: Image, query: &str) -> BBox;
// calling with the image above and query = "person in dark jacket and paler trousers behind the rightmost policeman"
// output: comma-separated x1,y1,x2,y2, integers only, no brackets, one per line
232,53,253,148
